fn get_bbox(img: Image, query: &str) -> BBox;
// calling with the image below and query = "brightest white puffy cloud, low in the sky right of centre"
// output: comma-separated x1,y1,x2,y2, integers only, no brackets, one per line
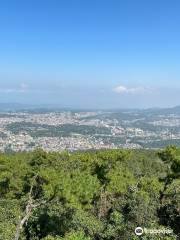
113,85,148,94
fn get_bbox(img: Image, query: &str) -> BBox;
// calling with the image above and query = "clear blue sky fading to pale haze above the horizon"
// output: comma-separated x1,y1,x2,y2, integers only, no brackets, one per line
0,0,180,108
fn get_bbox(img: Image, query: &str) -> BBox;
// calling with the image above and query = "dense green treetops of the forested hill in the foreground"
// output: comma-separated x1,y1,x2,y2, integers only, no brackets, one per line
0,147,180,240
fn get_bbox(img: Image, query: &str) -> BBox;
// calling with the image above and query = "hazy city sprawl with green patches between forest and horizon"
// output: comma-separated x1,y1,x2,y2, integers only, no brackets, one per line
0,108,180,152
